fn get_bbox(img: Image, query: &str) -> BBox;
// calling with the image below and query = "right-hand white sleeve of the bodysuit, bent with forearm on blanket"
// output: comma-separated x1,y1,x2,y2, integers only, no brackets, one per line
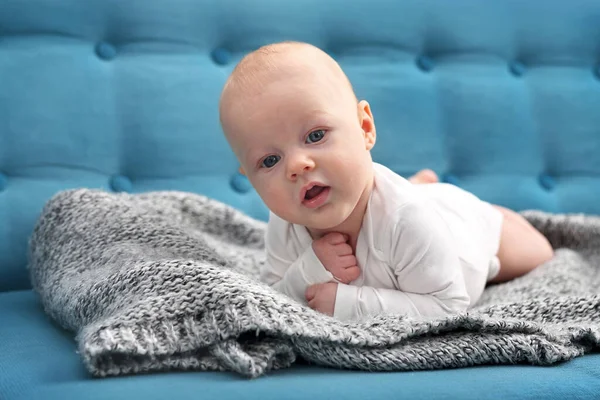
334,203,470,320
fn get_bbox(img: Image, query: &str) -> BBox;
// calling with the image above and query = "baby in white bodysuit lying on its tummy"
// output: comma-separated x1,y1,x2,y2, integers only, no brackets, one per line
219,42,553,320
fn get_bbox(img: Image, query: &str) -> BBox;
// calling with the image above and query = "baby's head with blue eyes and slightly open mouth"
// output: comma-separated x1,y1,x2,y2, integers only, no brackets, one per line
219,42,375,230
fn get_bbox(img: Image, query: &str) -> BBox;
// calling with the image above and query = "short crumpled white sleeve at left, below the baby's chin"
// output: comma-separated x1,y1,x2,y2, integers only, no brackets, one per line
260,216,334,304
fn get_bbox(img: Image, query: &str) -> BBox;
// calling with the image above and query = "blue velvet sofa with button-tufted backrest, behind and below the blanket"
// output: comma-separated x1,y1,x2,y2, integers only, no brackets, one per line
0,0,600,400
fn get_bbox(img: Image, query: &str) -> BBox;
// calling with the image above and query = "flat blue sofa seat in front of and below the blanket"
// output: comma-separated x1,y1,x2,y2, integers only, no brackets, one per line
0,291,600,400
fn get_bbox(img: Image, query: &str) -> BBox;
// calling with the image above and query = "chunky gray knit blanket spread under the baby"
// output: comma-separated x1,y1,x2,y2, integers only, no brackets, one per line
29,189,600,377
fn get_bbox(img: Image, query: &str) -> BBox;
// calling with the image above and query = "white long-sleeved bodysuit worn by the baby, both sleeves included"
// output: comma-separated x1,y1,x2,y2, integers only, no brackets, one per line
261,163,503,320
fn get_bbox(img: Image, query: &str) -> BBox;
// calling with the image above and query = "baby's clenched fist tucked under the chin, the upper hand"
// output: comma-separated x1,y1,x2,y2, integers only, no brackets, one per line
312,232,360,284
